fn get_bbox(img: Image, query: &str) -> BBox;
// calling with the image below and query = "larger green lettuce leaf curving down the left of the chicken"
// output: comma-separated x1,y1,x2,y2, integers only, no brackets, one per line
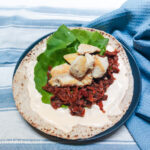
34,25,76,104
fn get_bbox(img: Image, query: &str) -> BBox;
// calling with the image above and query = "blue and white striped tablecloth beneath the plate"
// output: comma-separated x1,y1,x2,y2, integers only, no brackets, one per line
0,0,139,150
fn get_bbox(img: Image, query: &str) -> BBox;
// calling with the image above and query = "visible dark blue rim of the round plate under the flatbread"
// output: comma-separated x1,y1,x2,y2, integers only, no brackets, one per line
14,33,141,144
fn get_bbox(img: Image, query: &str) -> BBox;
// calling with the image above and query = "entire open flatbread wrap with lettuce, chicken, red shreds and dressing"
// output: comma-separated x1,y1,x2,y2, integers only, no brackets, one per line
13,25,133,139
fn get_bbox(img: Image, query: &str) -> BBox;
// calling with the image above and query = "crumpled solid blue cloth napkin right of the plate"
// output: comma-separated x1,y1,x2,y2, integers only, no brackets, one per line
86,0,150,150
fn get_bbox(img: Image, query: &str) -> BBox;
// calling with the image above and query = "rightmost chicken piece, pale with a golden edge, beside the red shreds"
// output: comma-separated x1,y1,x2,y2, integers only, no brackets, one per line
92,55,109,78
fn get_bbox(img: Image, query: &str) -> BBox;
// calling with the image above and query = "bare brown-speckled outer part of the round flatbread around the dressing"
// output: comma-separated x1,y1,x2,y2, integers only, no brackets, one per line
13,27,133,139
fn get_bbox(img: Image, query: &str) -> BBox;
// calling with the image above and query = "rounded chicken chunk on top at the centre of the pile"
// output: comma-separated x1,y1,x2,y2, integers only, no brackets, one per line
70,56,88,78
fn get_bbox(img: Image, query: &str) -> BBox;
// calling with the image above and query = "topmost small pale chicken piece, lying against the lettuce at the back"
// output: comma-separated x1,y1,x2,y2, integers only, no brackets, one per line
77,44,100,54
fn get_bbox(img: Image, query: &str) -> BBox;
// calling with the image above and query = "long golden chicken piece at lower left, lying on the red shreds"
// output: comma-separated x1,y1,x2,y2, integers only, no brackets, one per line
49,64,92,86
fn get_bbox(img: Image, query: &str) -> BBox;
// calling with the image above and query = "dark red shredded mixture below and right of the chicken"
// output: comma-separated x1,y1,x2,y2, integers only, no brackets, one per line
43,50,119,116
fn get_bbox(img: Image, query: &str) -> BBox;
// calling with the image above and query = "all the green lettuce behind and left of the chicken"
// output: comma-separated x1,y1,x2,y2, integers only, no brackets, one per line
34,25,108,104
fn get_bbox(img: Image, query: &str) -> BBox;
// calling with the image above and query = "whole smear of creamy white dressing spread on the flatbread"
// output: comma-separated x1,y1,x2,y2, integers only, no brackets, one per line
27,44,128,132
